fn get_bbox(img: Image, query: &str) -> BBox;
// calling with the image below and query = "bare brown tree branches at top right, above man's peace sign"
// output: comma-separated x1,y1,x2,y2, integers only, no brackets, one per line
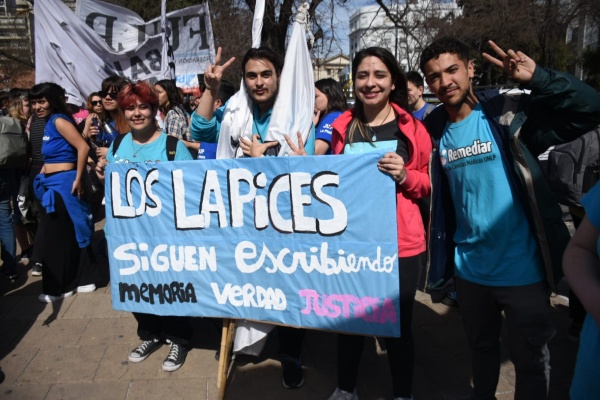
375,0,600,85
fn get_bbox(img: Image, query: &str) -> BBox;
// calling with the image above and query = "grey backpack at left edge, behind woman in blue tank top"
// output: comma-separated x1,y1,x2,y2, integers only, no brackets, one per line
0,116,28,169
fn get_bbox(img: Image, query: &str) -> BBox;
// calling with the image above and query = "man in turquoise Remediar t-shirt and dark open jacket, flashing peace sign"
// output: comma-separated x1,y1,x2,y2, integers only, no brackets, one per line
420,38,600,399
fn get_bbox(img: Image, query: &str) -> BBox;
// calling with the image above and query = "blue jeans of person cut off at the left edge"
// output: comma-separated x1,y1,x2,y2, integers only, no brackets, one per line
0,170,17,272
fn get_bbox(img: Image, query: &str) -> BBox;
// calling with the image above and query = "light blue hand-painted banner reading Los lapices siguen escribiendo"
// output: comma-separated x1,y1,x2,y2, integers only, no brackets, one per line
106,152,400,336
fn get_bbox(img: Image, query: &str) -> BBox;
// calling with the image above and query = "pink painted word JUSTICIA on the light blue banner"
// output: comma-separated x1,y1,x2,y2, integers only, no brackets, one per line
298,289,397,324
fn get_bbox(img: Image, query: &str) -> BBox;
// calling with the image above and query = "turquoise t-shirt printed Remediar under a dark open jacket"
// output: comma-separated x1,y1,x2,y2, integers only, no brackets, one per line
440,104,544,286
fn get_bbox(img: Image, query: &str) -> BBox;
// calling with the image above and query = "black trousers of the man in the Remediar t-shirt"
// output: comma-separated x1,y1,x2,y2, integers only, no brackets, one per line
456,277,556,400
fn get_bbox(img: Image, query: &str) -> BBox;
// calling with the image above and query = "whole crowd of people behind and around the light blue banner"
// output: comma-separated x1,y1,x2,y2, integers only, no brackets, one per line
0,38,600,400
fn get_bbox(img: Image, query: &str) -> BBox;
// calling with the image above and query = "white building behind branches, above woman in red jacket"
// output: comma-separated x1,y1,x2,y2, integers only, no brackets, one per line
350,0,462,71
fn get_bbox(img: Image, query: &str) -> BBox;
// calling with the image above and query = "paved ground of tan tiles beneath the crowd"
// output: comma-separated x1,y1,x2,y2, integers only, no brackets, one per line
0,244,577,400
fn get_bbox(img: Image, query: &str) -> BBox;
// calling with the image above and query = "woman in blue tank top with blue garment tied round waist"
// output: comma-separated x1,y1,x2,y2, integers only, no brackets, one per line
29,82,96,303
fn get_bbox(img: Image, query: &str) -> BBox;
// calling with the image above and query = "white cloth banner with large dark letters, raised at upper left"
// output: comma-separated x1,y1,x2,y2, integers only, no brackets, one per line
34,0,215,105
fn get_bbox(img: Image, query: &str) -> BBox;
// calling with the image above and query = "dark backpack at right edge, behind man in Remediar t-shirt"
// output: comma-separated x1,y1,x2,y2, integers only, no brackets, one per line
546,127,600,207
